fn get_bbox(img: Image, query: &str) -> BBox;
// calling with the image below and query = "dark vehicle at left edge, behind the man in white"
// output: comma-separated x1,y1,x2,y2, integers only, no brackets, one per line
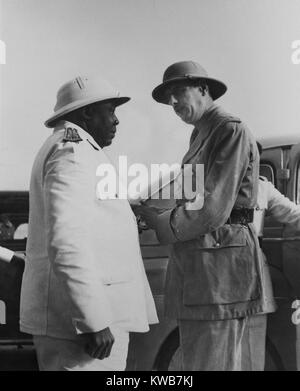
0,191,38,371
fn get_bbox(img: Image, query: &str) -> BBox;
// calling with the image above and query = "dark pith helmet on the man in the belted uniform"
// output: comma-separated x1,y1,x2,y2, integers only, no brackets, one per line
152,61,227,104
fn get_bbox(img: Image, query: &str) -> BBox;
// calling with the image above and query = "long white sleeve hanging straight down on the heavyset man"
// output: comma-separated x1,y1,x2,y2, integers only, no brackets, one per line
43,143,112,334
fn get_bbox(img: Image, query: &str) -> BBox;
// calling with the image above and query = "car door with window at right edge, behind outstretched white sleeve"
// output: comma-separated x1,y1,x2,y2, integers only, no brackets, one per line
261,144,300,370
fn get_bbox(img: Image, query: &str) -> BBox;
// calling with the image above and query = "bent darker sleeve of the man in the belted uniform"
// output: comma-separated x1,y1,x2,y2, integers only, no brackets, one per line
156,122,250,243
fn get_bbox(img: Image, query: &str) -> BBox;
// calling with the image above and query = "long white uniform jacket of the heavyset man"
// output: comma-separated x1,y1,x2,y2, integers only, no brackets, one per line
20,122,158,338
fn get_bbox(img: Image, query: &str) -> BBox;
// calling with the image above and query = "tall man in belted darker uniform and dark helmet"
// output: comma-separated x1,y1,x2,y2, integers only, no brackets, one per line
136,61,275,370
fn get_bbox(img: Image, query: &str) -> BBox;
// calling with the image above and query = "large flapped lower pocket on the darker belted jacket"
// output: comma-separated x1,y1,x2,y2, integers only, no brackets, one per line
183,225,260,305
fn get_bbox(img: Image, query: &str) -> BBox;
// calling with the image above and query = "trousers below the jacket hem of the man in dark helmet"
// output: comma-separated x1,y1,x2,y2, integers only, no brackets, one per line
178,314,266,371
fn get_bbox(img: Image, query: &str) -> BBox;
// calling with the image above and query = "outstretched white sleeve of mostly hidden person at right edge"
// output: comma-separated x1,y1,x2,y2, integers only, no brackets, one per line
265,182,300,230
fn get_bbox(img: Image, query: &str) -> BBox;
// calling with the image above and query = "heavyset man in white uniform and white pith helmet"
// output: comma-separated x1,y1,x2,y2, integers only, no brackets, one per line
20,77,157,371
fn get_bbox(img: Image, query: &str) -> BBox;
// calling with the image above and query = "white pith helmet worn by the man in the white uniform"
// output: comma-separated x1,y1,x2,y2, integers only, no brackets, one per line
45,76,130,128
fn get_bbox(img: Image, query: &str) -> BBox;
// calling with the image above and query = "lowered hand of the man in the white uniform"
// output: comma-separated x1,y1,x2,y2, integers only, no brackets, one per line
81,327,115,360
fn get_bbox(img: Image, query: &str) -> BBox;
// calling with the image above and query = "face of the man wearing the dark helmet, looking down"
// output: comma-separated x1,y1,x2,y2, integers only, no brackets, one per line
166,84,209,125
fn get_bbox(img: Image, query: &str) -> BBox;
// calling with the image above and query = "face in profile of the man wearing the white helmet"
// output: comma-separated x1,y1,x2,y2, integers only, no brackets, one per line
88,103,119,148
